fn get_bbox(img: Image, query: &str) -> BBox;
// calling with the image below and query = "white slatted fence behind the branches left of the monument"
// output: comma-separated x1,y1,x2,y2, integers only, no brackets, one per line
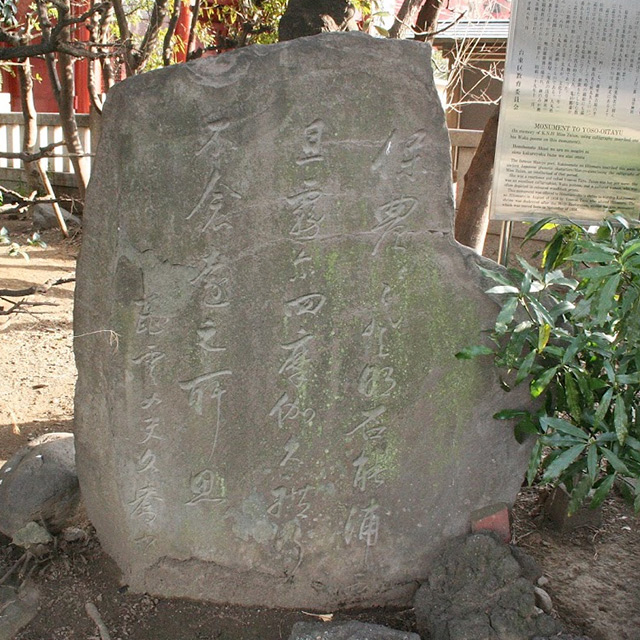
0,113,91,187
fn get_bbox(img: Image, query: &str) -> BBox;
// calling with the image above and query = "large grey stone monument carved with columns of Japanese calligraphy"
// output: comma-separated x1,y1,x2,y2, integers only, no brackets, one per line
75,34,527,608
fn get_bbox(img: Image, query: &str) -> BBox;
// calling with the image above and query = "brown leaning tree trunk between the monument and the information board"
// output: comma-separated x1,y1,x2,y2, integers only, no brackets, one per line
455,105,500,254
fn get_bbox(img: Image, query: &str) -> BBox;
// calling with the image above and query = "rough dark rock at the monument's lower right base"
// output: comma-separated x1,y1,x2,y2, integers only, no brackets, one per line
414,534,560,640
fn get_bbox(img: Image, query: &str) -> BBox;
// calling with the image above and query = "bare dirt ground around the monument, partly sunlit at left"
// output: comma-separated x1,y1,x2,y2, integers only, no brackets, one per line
0,217,640,640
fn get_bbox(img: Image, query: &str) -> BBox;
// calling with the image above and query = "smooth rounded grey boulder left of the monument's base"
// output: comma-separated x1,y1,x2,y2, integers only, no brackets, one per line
0,433,80,538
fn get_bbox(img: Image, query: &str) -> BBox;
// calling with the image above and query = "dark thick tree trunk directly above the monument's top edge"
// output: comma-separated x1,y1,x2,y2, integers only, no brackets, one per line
278,0,351,42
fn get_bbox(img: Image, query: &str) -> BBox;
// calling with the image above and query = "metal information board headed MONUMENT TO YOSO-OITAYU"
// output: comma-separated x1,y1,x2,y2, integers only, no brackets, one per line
491,0,640,223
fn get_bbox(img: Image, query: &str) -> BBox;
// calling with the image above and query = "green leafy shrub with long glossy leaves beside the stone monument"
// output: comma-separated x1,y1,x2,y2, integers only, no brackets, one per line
456,216,640,512
